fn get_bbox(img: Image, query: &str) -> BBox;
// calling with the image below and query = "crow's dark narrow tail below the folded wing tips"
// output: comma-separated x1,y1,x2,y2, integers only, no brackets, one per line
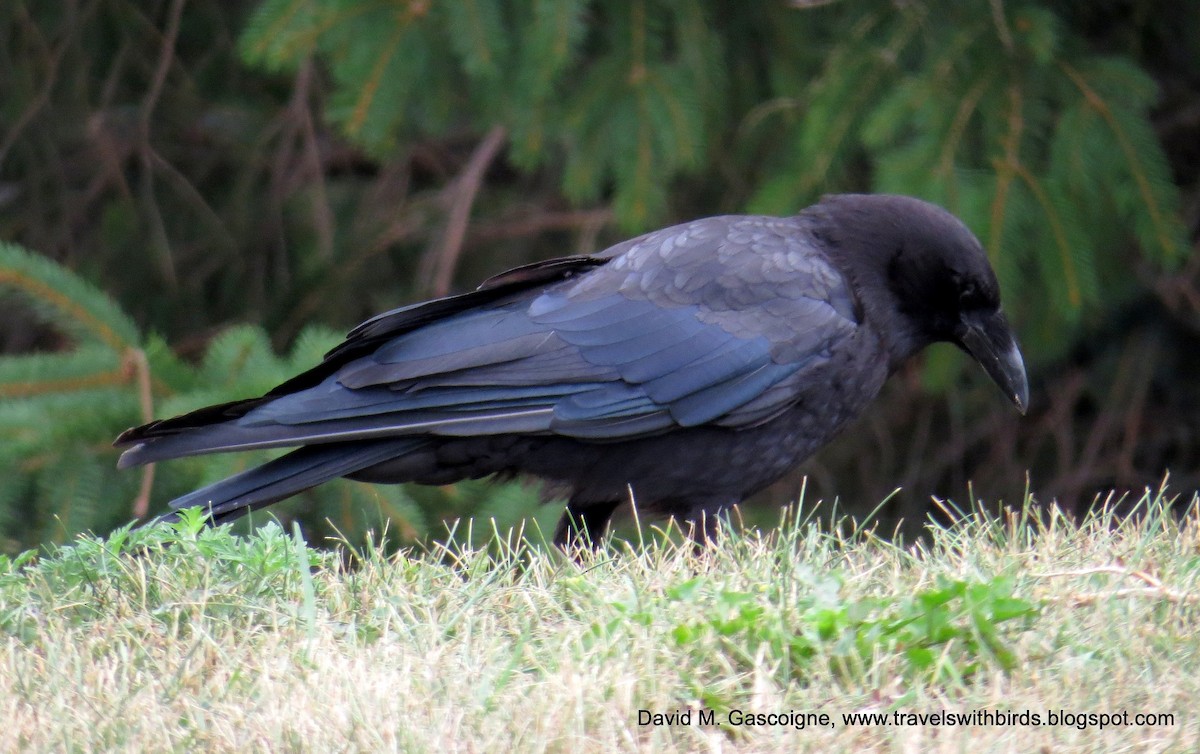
158,437,428,526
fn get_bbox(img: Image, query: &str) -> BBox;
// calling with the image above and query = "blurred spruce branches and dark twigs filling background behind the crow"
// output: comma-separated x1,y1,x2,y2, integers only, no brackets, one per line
0,0,1200,551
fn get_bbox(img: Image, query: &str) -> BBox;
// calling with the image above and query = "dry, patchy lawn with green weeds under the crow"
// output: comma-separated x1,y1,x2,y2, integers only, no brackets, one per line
0,492,1200,754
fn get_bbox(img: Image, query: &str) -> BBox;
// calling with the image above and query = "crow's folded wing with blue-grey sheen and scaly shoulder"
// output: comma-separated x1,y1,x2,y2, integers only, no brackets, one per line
117,219,857,462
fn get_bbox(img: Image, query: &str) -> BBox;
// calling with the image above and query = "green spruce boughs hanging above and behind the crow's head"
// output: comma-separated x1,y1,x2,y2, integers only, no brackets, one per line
751,1,1188,372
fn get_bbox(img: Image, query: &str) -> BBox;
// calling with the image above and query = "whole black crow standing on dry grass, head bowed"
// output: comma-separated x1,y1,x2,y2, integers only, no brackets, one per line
115,195,1028,546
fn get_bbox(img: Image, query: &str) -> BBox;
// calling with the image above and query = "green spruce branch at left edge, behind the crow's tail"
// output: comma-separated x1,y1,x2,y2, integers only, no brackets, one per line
0,244,142,550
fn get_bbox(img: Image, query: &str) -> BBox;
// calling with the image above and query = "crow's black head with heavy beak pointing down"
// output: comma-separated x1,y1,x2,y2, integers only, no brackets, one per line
811,195,1030,413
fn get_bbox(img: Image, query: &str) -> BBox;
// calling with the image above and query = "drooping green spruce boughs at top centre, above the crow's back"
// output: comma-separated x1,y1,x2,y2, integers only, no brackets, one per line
241,0,725,229
